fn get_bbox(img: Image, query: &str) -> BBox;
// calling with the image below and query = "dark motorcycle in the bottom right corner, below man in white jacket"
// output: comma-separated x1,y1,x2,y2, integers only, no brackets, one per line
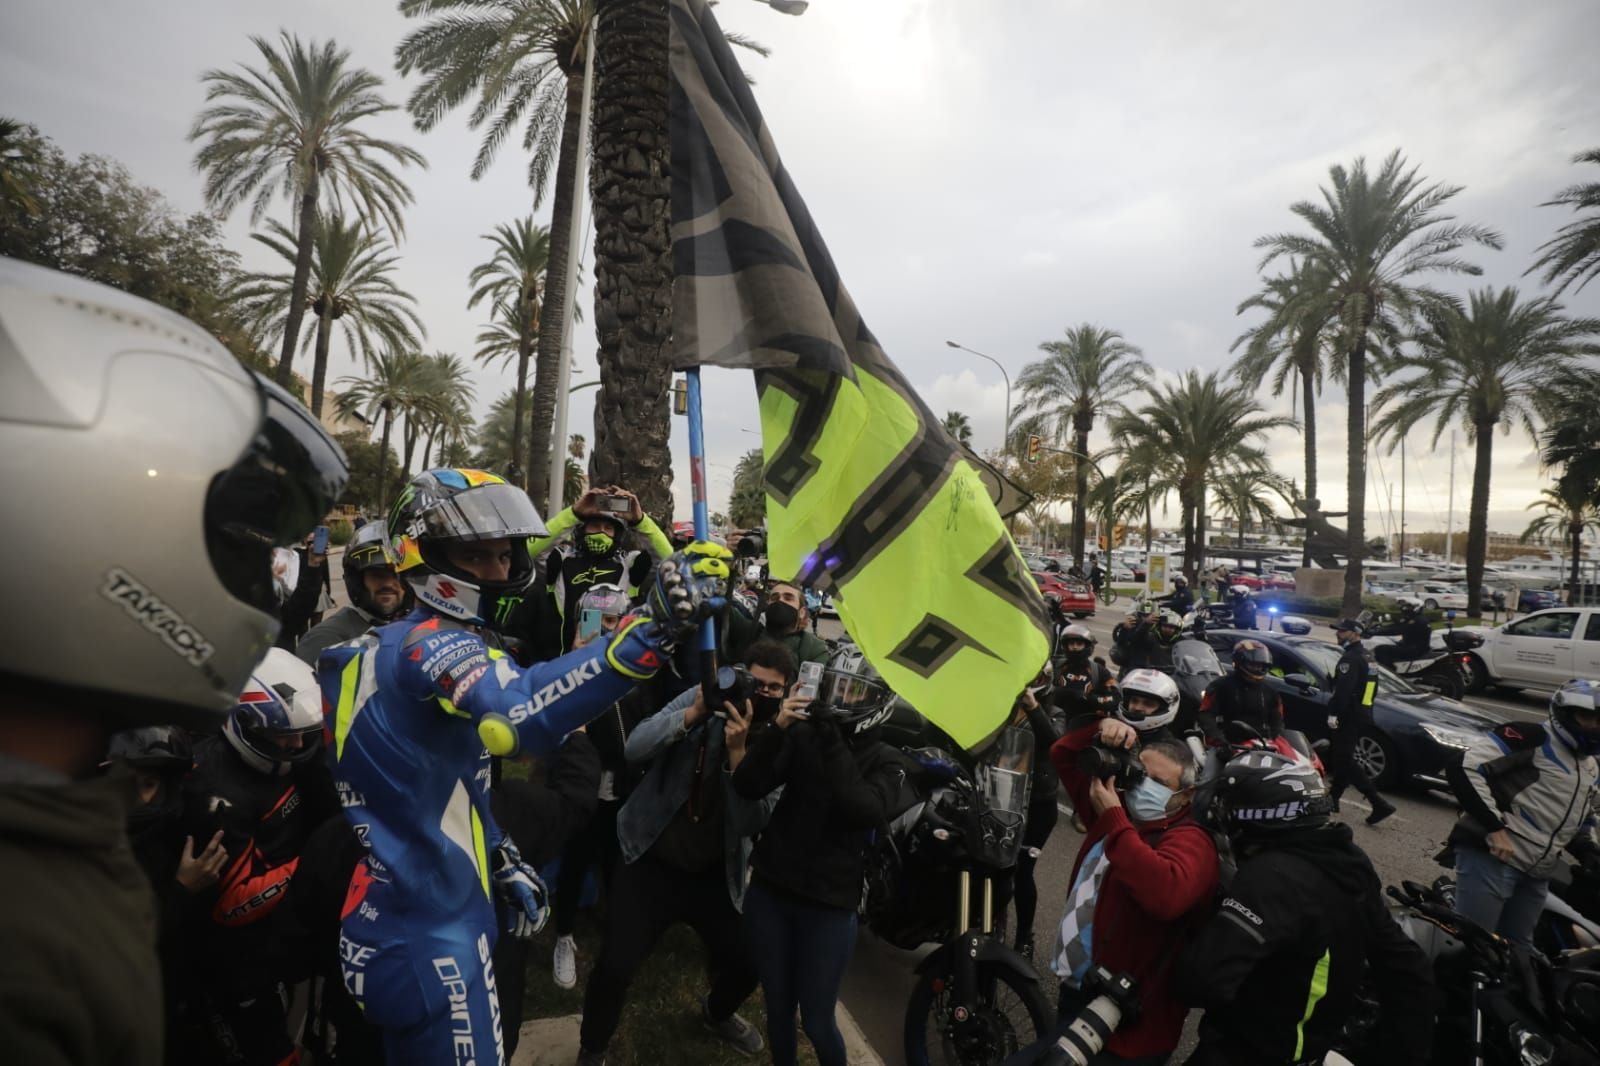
1363,879,1600,1066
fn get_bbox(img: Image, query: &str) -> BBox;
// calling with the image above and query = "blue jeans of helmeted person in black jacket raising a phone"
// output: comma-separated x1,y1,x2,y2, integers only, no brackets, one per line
744,879,856,1066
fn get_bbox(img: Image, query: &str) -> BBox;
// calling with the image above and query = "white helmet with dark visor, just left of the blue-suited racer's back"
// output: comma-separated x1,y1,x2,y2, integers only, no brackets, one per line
222,648,322,776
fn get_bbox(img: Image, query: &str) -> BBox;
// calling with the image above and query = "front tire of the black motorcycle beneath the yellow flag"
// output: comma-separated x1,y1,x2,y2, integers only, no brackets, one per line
906,962,1056,1066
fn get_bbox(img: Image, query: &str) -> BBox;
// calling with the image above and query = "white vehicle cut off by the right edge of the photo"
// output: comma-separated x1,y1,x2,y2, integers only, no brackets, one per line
1461,607,1600,691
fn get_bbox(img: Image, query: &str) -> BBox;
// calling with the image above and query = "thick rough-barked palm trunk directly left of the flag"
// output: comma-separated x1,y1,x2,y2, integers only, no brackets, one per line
595,0,672,522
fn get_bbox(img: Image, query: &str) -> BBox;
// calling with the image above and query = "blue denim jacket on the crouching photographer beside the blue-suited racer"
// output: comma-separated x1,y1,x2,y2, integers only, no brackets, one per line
616,688,782,911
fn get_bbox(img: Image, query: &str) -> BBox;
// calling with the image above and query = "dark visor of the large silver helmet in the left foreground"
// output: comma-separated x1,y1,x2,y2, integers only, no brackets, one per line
205,375,350,613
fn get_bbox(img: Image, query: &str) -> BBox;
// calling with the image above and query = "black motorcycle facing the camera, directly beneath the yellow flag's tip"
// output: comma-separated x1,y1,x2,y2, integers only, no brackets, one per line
862,707,1056,1066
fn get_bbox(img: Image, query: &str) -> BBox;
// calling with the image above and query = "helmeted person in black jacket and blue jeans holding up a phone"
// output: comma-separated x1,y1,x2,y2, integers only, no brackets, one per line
733,647,909,1066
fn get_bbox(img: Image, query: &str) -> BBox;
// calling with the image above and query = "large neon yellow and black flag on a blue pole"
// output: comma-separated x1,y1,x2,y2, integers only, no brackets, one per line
670,0,1050,746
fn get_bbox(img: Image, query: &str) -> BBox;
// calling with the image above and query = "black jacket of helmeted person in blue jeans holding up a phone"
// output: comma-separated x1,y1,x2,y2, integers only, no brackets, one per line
733,722,907,911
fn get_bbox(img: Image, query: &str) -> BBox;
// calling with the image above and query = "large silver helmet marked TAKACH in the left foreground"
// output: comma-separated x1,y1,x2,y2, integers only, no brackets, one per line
0,258,347,730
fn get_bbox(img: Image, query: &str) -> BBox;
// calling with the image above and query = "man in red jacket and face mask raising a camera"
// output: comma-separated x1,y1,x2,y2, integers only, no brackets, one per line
1050,719,1218,1066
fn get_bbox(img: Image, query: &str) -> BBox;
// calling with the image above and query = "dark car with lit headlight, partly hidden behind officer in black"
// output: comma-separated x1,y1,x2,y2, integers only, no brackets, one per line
1205,629,1496,787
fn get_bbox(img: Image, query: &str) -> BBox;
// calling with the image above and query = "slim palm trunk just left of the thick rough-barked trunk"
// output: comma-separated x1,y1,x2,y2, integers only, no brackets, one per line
517,73,585,504
